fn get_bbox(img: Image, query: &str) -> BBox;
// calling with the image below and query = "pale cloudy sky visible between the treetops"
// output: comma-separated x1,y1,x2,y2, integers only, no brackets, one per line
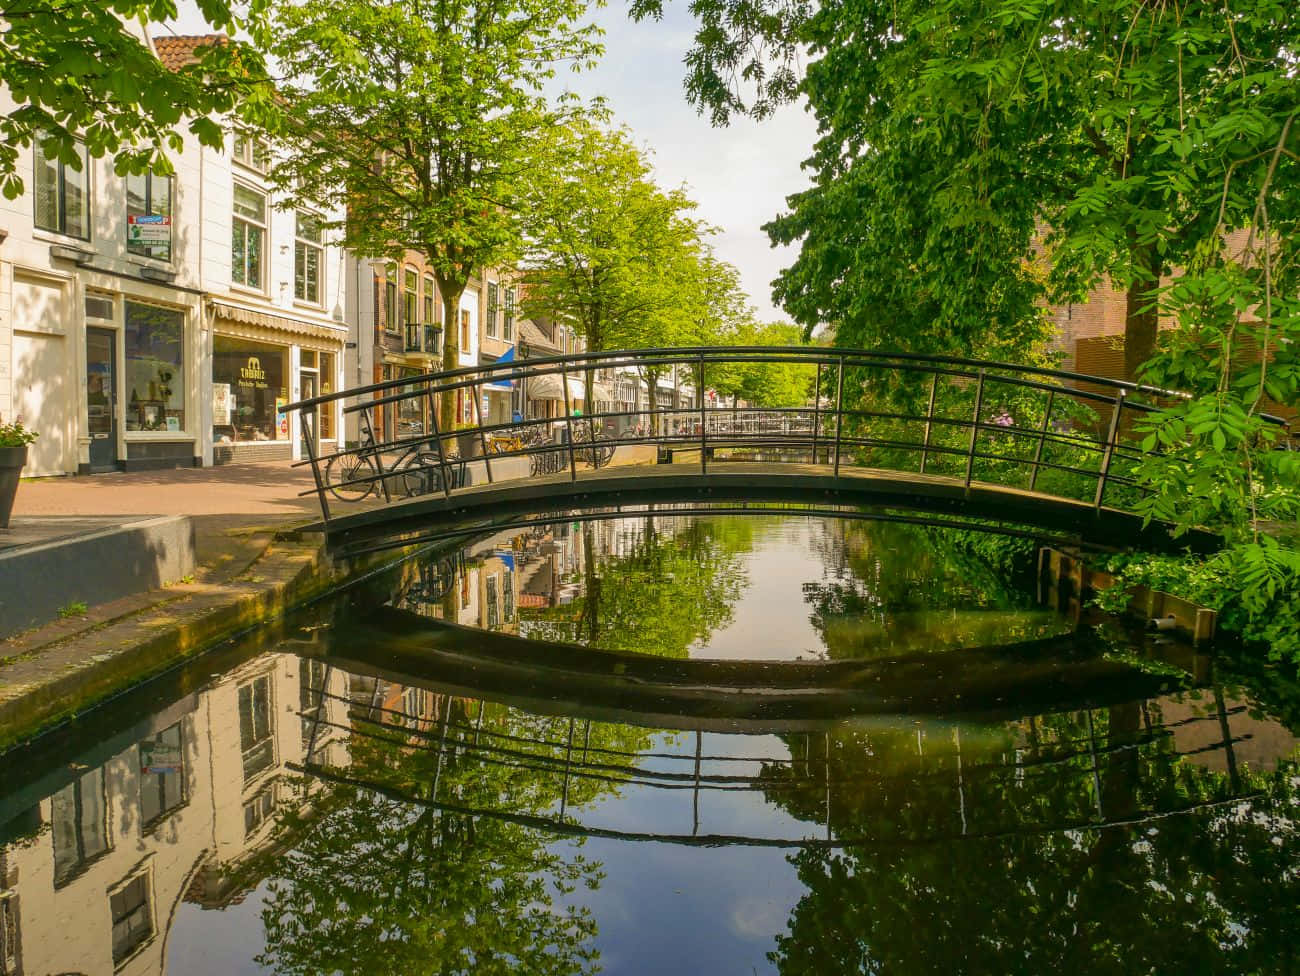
168,0,816,321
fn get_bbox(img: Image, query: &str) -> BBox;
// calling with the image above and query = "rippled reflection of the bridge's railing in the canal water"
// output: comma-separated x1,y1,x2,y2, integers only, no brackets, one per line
294,642,1289,850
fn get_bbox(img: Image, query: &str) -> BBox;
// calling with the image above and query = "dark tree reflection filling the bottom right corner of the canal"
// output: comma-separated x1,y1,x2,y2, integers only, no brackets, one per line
767,703,1300,973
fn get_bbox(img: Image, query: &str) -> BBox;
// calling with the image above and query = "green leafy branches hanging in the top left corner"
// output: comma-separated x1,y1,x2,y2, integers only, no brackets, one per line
0,0,270,200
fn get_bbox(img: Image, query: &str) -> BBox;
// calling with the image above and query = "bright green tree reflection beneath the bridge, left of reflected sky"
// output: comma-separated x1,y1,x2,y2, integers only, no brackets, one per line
520,517,754,658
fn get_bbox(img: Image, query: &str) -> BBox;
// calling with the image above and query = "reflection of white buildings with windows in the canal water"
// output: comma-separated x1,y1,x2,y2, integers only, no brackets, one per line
0,654,347,973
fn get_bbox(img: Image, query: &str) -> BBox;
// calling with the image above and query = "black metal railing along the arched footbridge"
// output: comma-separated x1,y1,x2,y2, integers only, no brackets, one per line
285,347,1284,524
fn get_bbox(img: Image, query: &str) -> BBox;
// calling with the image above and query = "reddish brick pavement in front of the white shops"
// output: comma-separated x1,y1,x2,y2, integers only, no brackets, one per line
13,461,320,522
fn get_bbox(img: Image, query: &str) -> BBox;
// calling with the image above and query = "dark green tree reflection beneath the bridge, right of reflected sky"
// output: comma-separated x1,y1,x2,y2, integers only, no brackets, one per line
803,521,1062,659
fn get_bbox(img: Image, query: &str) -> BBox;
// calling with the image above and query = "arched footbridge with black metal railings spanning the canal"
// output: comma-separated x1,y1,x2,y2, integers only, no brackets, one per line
286,347,1263,552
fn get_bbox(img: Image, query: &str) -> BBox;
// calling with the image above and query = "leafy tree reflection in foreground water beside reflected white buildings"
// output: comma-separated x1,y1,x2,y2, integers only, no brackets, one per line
260,697,660,976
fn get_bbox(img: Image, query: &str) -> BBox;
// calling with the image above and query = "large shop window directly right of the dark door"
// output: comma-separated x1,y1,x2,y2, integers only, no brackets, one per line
125,302,185,431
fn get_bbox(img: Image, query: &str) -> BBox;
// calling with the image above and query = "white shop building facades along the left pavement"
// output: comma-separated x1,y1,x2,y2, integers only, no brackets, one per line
0,29,347,477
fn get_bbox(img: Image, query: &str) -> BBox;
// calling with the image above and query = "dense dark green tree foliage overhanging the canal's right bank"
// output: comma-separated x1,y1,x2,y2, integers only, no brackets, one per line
633,0,1300,660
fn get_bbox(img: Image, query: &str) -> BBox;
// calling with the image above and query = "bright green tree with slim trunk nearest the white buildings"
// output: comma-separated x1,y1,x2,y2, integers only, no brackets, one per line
272,0,599,429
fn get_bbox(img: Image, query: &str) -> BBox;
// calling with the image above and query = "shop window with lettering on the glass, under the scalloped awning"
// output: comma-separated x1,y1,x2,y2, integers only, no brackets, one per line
212,335,289,444
